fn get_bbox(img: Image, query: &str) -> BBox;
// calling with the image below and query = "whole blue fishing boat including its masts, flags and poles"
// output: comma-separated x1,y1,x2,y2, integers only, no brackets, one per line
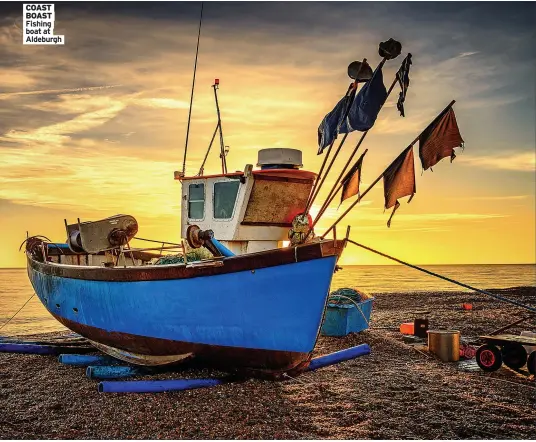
26,31,493,377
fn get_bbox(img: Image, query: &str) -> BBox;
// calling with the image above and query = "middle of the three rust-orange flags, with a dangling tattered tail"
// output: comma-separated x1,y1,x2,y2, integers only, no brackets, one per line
383,145,417,227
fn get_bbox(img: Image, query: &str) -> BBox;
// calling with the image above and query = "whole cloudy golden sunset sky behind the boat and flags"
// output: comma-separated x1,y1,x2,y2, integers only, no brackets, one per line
0,2,536,267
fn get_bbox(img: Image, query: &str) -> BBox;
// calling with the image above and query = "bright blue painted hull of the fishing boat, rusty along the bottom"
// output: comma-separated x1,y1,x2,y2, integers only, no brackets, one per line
28,240,339,371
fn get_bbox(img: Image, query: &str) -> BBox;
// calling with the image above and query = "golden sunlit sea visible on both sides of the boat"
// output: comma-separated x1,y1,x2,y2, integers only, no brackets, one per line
0,264,536,337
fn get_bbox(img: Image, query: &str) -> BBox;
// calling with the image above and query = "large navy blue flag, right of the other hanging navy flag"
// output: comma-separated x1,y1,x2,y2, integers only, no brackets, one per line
339,66,387,133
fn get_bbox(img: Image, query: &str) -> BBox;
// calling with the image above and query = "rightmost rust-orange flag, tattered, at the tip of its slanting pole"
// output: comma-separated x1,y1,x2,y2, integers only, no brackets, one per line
419,106,463,170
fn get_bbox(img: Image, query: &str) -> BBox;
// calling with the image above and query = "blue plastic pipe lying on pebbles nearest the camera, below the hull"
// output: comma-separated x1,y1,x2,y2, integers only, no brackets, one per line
98,379,222,393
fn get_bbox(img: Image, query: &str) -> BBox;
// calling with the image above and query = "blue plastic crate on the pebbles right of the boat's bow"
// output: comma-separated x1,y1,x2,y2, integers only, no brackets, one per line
320,298,374,336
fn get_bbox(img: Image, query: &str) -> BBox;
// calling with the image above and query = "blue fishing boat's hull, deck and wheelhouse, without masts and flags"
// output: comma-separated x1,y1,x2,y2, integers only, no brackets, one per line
26,149,345,373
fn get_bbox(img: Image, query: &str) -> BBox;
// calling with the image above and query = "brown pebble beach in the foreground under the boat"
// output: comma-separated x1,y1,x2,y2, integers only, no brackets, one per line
0,287,536,439
